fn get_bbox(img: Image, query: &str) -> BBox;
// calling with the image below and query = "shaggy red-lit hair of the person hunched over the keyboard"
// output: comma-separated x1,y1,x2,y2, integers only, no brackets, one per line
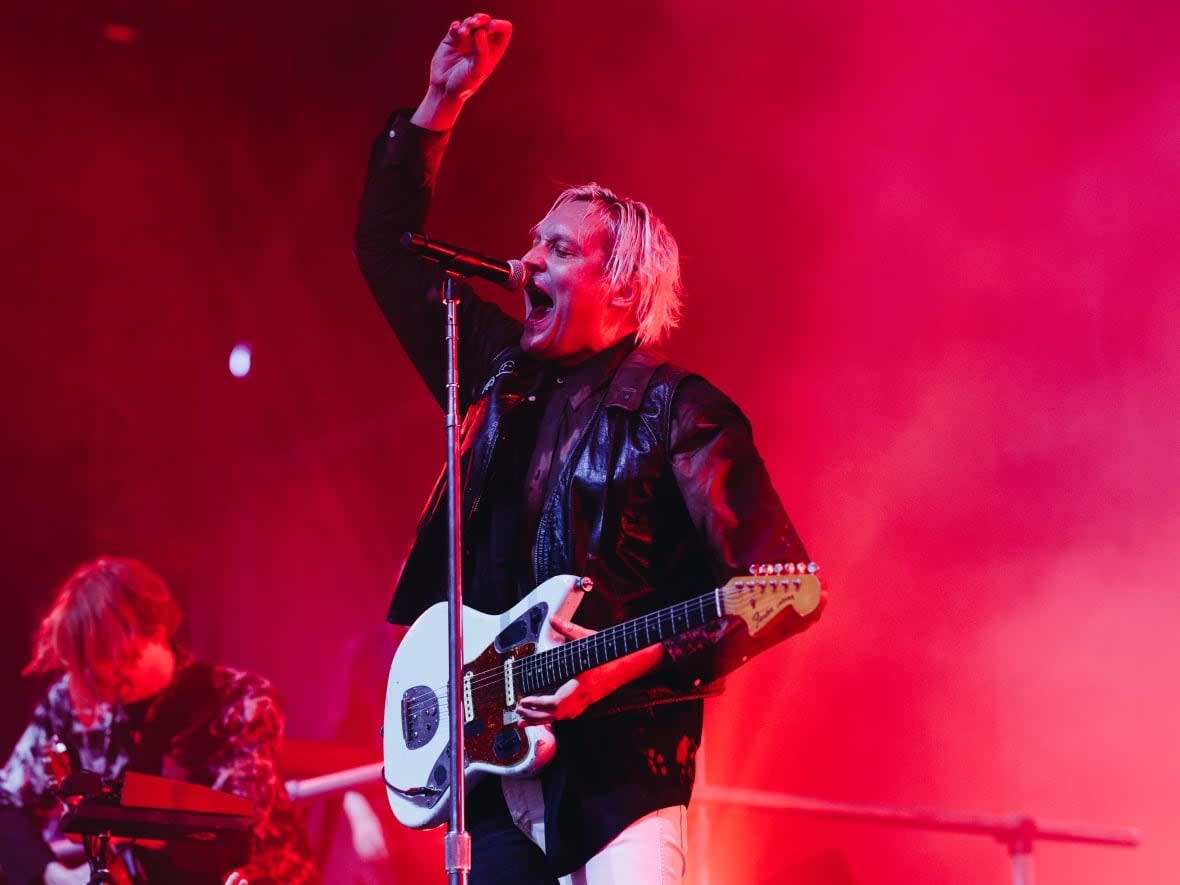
24,557,182,690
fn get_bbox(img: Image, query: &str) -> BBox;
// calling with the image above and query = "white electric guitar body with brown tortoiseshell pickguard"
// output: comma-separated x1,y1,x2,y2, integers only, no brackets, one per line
382,575,583,830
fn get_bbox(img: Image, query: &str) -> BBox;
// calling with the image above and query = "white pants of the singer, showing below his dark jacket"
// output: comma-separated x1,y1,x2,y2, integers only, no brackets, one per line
500,778,688,885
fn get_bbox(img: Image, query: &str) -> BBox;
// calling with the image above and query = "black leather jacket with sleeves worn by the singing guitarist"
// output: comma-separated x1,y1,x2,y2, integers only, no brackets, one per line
356,113,821,874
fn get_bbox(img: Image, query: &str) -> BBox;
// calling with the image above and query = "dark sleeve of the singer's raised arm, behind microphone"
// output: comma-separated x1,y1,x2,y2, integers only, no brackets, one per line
354,111,520,408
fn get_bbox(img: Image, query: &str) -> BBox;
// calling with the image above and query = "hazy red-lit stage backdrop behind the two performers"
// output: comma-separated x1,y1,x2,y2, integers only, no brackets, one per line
0,0,1180,885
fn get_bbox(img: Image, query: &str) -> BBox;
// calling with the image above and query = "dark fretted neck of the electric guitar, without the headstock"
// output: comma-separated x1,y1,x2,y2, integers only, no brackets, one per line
520,590,722,695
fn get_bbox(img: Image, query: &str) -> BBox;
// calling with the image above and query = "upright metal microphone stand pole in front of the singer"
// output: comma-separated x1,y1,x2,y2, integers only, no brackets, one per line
443,270,471,885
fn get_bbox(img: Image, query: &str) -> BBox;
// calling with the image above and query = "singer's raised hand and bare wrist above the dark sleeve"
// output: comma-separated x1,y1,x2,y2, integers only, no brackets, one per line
412,12,512,130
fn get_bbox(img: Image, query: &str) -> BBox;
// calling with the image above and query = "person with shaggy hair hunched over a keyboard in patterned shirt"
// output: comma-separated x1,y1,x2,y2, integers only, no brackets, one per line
0,557,320,885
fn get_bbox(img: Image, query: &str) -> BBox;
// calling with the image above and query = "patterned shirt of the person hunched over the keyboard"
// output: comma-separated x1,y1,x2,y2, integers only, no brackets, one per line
0,649,320,885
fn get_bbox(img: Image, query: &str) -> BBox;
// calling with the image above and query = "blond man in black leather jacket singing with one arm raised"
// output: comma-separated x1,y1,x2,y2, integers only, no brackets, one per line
356,14,819,885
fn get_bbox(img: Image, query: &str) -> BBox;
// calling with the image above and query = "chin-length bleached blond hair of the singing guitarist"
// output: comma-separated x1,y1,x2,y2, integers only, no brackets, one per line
549,182,683,345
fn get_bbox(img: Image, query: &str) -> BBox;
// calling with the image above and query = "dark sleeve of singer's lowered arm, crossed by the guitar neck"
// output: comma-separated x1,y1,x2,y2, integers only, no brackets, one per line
663,375,826,687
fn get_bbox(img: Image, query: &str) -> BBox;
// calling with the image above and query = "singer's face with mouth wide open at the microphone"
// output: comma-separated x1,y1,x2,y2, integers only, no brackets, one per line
520,201,620,362
